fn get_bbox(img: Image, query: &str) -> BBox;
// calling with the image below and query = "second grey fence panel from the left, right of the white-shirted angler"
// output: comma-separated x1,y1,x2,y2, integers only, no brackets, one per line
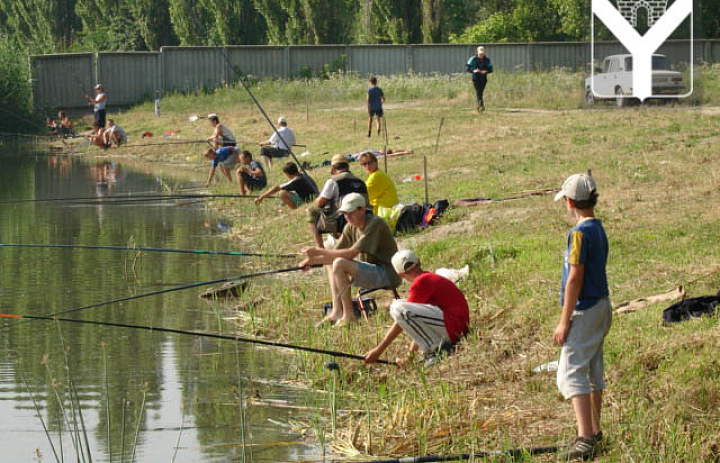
97,52,162,106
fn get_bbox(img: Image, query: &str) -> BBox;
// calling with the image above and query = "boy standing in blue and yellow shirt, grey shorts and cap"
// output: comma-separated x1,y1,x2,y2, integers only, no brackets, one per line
553,174,612,460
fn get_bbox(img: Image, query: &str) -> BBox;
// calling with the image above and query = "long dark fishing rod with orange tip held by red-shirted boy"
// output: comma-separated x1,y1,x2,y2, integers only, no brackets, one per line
0,314,396,365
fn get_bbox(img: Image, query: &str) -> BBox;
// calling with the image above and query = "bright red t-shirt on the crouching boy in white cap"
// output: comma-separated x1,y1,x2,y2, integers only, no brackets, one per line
407,272,470,343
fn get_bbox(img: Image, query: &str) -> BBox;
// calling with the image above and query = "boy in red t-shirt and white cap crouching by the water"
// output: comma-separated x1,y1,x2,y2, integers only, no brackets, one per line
365,250,470,367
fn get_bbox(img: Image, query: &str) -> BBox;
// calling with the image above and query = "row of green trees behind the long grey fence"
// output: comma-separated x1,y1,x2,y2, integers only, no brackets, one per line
0,0,720,53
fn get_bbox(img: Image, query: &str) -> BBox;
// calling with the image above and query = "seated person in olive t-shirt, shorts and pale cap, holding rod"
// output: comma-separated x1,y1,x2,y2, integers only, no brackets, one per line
300,193,401,326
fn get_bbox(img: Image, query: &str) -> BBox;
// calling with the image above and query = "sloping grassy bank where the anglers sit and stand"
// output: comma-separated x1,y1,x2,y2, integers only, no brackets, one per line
71,68,720,461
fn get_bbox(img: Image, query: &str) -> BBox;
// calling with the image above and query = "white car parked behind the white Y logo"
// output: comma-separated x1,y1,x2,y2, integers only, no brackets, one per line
585,55,685,106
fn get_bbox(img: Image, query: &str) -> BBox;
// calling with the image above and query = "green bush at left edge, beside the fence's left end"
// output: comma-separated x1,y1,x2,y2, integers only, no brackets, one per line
0,35,35,132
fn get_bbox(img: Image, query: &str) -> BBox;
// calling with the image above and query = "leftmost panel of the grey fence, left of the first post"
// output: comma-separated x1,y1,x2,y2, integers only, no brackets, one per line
30,53,95,110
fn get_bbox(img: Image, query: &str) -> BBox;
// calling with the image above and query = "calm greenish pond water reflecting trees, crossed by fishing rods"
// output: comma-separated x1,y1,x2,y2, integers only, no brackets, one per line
0,147,321,462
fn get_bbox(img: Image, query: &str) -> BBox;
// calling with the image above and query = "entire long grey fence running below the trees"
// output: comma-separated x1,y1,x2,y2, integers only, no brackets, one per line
30,40,720,110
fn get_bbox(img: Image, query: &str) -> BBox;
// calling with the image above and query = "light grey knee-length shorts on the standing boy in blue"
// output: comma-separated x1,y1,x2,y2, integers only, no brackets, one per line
557,298,612,399
